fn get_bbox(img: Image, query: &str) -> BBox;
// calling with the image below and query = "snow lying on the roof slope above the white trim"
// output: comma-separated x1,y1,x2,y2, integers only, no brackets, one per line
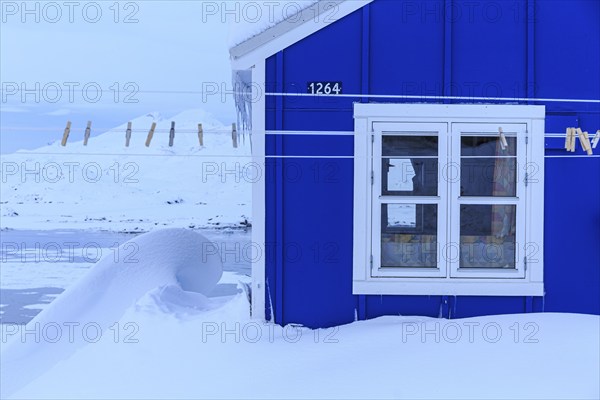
229,0,318,49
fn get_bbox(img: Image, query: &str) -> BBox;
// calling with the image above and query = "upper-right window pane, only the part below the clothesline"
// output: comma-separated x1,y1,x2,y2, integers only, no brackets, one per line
460,158,517,197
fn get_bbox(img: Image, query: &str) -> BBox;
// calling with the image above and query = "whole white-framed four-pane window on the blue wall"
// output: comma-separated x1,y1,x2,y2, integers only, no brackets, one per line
353,104,544,295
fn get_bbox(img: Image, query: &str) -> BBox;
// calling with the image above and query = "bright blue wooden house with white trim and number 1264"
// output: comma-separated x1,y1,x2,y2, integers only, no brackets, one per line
230,0,600,327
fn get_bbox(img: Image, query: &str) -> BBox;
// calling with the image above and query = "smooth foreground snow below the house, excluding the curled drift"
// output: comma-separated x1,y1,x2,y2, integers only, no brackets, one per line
2,298,600,399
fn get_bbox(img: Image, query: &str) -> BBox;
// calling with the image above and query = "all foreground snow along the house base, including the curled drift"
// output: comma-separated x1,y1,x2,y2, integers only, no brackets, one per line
0,229,600,399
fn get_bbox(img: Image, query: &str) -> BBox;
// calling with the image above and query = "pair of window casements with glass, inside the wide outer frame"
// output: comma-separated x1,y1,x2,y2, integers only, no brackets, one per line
371,124,526,278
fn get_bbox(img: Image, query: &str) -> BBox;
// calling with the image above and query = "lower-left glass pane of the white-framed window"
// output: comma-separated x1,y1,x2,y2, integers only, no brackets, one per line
381,204,437,268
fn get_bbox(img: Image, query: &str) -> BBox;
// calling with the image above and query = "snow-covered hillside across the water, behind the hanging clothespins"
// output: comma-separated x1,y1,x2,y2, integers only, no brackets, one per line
0,110,253,232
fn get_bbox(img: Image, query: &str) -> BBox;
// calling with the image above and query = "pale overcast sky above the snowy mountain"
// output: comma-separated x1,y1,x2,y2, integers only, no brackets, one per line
0,1,235,153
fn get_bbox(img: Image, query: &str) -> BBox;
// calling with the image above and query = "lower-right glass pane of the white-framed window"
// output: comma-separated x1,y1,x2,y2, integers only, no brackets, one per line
459,204,517,269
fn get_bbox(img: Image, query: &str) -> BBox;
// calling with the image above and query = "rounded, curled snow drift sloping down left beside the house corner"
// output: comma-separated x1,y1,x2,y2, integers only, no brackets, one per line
0,229,223,398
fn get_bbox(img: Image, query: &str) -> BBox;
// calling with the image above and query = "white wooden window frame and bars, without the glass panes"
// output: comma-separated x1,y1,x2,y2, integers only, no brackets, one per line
353,104,545,296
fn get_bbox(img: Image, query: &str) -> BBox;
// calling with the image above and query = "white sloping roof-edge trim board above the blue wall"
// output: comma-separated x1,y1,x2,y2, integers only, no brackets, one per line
229,0,374,69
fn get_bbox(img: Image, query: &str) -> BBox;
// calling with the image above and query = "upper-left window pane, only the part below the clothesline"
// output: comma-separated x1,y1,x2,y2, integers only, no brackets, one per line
381,158,438,196
